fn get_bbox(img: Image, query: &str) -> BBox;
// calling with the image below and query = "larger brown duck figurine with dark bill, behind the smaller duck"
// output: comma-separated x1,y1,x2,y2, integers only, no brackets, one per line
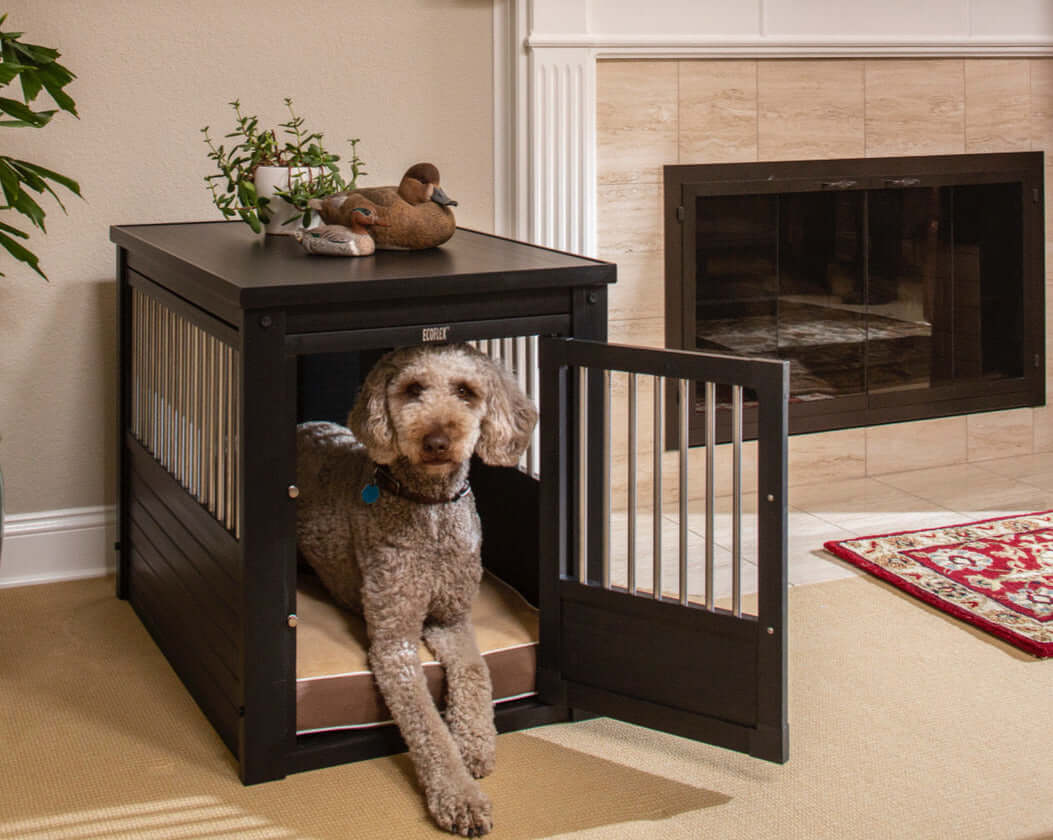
309,163,457,251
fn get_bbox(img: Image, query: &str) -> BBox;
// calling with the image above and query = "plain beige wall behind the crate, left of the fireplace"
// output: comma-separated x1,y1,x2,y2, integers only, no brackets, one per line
0,0,493,513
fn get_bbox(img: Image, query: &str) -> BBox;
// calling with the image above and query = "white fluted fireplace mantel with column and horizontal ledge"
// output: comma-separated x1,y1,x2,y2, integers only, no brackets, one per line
494,0,1053,256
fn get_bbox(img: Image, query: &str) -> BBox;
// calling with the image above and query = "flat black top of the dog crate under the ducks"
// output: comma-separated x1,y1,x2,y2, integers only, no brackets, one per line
110,222,615,309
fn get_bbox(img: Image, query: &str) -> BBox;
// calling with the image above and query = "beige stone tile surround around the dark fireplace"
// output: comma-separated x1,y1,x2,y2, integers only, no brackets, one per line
596,58,1053,507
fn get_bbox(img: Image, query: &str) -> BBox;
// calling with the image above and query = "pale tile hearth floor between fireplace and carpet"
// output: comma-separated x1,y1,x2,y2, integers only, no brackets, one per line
611,453,1053,618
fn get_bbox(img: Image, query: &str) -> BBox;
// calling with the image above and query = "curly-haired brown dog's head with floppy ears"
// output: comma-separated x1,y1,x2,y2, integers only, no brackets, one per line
347,344,537,474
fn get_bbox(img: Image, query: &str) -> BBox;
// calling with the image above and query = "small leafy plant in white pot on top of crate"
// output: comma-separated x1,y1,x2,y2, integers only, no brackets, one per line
201,98,364,234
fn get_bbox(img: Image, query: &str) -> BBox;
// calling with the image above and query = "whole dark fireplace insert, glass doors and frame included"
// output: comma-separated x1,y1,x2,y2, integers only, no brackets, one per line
664,152,1045,444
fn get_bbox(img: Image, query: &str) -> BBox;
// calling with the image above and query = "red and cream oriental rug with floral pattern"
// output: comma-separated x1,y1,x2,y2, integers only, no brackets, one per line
824,511,1053,658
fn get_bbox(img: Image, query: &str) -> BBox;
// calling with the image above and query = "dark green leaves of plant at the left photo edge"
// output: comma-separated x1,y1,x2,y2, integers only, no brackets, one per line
0,15,80,280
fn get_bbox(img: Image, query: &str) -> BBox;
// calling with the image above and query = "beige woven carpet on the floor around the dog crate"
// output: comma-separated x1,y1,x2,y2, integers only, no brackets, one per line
0,579,1053,840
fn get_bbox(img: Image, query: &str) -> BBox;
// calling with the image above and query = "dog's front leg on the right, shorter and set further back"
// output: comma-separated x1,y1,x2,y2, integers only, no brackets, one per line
424,618,497,779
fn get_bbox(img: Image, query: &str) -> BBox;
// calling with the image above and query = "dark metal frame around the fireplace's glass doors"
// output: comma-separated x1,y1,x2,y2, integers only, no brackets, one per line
664,152,1046,445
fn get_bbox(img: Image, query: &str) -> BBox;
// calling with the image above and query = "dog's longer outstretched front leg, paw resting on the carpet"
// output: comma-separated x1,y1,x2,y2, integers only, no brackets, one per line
370,633,493,837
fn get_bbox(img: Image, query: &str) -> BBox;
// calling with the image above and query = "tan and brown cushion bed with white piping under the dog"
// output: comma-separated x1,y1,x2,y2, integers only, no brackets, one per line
296,572,537,735
